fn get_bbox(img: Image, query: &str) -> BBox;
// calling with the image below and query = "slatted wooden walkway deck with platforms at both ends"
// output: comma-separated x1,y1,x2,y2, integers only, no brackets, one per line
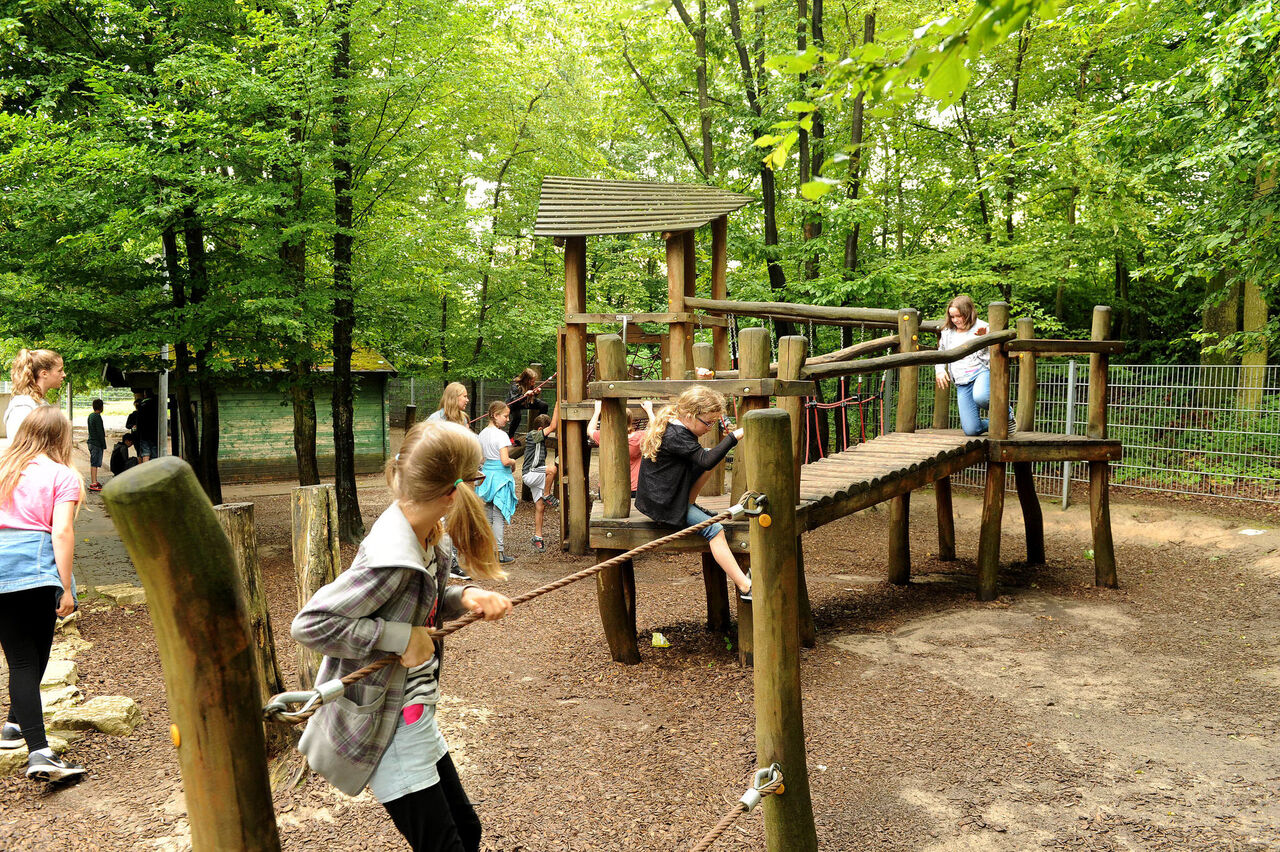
590,429,1123,553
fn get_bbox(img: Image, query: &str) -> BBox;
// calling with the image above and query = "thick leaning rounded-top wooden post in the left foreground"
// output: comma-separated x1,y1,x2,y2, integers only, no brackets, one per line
102,455,280,852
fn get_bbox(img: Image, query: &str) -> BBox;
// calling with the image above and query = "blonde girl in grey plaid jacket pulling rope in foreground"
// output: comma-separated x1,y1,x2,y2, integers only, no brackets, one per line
292,422,511,852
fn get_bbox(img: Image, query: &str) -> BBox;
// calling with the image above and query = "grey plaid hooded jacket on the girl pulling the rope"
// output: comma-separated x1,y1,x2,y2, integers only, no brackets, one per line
291,503,466,796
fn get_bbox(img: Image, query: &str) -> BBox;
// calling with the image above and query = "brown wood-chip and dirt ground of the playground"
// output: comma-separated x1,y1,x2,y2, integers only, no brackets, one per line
0,434,1280,852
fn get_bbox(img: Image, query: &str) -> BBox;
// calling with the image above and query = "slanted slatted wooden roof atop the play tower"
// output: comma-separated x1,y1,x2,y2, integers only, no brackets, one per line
534,177,755,237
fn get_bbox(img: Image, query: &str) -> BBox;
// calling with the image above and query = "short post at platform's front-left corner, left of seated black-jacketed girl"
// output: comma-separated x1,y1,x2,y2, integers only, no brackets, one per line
595,334,640,665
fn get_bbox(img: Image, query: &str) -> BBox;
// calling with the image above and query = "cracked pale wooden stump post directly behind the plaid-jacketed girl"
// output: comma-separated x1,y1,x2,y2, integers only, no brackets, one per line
291,485,342,690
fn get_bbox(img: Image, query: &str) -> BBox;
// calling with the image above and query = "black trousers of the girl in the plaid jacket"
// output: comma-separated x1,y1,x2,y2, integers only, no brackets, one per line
383,755,480,852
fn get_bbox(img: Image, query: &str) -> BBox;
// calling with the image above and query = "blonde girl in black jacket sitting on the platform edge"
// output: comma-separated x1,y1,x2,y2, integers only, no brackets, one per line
636,385,751,601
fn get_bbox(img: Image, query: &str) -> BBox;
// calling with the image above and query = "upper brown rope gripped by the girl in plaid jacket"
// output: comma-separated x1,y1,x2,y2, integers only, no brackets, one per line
262,491,765,723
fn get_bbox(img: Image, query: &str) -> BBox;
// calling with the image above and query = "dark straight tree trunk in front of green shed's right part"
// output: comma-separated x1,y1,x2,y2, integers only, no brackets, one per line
333,0,365,542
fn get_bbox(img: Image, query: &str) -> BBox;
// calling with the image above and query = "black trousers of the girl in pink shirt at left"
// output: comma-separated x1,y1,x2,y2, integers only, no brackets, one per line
0,586,61,751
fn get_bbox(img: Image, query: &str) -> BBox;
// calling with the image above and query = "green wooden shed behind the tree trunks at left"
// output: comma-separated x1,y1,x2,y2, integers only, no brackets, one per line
113,348,396,484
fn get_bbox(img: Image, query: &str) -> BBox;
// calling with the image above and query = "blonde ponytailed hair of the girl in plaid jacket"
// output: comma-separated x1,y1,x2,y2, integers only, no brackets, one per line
387,421,507,580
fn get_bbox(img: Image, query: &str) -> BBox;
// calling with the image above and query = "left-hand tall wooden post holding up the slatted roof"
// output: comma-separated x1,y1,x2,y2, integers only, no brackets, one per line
561,237,591,556
